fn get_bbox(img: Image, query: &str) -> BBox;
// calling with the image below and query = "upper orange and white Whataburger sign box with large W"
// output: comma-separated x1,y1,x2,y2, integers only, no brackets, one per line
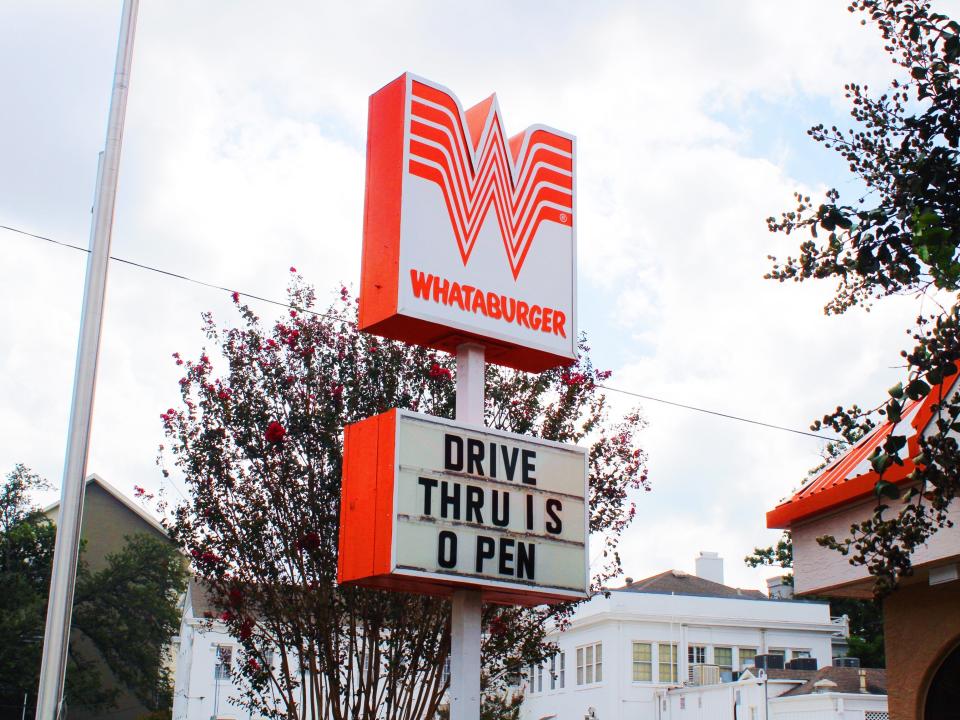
360,73,577,372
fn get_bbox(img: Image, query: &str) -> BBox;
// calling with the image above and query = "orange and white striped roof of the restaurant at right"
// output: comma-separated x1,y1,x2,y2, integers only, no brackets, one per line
767,374,960,528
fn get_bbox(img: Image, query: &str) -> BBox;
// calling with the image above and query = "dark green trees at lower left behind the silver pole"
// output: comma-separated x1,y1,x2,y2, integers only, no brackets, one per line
0,465,185,717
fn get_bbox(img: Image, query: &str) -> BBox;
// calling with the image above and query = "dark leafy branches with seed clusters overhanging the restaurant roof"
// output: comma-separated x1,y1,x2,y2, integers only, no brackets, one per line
768,0,960,595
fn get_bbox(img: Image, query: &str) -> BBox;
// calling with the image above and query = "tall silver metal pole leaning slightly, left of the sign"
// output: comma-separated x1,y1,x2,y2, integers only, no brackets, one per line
36,0,139,720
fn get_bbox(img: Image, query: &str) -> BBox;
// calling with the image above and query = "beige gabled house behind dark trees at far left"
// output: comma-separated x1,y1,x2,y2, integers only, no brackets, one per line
44,474,176,720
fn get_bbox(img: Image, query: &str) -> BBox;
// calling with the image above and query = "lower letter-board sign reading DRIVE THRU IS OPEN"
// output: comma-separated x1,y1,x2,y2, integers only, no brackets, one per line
337,410,589,605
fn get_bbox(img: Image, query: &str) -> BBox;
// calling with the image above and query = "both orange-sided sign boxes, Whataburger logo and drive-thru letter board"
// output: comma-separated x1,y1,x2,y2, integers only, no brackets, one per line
337,74,589,605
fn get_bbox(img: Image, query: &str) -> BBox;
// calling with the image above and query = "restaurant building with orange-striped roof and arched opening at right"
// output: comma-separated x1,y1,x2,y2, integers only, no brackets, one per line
767,375,960,720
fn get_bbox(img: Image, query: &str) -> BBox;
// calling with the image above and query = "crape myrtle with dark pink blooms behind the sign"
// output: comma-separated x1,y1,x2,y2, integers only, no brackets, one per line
159,276,648,720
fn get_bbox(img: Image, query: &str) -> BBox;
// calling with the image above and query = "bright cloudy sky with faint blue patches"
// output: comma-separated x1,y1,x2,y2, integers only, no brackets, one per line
0,0,960,588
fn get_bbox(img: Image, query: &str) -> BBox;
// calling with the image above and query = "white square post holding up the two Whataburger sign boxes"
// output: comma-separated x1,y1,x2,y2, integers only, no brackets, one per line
450,343,486,720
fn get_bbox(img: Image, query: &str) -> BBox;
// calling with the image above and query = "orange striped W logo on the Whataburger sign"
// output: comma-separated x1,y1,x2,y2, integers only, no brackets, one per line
409,80,573,279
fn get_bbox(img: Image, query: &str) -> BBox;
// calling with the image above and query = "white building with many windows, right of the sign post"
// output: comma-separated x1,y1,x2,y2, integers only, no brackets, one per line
522,553,838,720
